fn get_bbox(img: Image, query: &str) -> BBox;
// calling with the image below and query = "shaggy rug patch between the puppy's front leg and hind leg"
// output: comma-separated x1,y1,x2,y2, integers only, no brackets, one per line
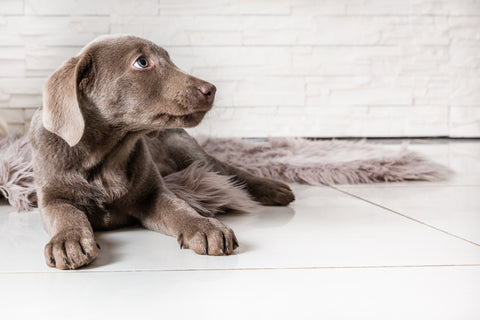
163,162,260,217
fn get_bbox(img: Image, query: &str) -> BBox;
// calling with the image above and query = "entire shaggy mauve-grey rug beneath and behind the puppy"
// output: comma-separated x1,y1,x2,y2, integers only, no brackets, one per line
0,136,452,215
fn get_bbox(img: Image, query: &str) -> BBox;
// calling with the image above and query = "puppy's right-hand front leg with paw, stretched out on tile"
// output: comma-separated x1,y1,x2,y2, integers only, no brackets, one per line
140,194,238,256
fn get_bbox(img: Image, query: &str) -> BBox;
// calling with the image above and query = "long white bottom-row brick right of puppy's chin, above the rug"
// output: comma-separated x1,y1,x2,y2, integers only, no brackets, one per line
190,106,448,137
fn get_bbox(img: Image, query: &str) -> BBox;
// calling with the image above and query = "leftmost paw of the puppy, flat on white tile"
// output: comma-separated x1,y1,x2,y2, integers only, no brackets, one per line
45,229,100,270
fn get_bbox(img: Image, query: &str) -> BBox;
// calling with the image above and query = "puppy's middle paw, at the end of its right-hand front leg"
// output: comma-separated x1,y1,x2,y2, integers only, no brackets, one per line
177,217,238,256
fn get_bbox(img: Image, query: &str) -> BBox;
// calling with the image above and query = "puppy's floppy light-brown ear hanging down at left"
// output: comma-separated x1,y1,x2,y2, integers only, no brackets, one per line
42,53,94,147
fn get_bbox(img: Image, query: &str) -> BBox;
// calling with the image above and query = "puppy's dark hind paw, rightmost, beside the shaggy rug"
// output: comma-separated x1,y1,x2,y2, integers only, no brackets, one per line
247,179,295,206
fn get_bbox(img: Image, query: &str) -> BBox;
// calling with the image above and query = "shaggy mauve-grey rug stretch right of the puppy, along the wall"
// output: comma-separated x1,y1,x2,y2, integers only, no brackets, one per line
196,136,454,185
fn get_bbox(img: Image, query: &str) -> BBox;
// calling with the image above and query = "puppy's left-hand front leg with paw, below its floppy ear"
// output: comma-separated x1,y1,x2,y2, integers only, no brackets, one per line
40,203,98,269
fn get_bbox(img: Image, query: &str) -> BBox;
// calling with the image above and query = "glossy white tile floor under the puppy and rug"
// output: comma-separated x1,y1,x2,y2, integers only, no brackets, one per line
0,141,480,320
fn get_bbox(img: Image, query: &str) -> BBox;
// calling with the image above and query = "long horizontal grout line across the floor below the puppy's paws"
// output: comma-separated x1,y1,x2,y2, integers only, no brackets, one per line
0,263,480,275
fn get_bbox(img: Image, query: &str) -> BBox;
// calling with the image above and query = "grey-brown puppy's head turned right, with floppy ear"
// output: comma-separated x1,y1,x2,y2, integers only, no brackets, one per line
42,36,216,146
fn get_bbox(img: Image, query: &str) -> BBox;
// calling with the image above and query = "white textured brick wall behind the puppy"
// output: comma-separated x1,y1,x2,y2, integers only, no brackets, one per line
0,0,480,137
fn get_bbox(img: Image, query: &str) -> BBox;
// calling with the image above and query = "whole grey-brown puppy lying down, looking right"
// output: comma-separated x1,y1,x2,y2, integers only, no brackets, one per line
29,36,294,269
